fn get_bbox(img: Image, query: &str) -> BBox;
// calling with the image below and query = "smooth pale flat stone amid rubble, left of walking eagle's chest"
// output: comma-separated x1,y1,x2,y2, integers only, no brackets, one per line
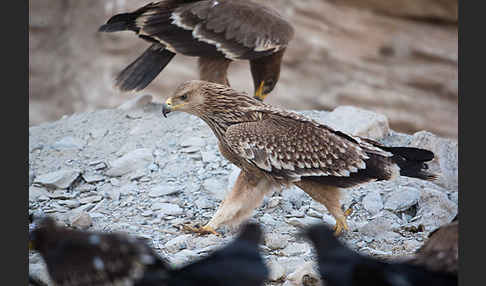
106,148,153,177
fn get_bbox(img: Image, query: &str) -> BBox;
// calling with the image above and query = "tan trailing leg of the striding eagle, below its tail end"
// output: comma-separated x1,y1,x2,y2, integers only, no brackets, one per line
294,179,352,235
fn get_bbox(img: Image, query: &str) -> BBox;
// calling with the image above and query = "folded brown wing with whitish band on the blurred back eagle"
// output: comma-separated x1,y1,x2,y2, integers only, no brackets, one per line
137,0,294,59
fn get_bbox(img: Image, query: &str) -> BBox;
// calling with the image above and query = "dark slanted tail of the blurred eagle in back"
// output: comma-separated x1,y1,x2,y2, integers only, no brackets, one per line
116,43,175,91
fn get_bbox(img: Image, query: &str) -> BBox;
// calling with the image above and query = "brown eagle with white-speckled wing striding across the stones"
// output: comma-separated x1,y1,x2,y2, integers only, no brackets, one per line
163,81,436,234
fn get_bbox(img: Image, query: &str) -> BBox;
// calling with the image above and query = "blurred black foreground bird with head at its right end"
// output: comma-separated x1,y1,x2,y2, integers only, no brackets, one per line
170,223,268,286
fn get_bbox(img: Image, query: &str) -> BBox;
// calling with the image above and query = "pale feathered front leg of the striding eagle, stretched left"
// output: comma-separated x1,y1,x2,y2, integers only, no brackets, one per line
191,171,273,233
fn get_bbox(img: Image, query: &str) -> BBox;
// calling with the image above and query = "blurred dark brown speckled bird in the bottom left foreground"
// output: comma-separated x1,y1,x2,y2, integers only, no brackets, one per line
30,217,168,286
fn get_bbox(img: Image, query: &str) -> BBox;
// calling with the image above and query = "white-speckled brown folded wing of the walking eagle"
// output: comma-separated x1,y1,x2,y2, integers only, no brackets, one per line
225,110,390,181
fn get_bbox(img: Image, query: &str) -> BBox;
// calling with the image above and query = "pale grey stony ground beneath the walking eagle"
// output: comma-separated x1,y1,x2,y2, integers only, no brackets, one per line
29,96,458,286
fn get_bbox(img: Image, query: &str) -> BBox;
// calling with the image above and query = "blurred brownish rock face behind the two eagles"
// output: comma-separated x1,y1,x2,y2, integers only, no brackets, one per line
29,0,458,138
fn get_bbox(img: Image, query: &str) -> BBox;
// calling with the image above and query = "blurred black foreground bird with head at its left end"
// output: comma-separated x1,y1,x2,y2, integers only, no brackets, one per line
305,225,458,286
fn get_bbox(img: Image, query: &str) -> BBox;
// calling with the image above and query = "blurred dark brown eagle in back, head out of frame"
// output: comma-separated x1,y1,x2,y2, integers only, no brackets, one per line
99,0,294,100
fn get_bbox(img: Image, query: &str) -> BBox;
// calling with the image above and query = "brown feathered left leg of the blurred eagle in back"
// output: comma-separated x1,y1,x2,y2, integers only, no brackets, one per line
198,57,231,86
